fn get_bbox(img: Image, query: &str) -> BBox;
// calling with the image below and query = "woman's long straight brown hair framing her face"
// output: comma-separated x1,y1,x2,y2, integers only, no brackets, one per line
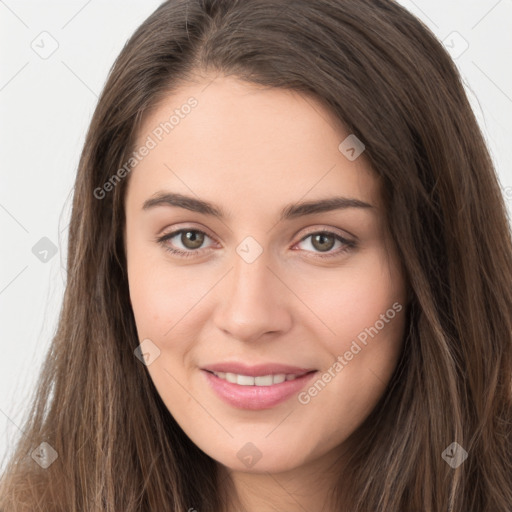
0,0,512,512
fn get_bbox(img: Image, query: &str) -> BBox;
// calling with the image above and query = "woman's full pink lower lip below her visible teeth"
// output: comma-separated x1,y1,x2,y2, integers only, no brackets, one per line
201,370,317,411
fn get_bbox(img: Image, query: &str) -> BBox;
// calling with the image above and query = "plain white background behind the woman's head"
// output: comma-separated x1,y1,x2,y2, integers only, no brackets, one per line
0,0,512,471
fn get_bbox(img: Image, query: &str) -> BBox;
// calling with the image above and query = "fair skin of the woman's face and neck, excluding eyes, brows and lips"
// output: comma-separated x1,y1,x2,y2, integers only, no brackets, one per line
125,76,406,512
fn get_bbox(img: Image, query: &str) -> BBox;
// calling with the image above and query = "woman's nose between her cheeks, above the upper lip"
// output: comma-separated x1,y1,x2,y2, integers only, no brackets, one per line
213,248,293,342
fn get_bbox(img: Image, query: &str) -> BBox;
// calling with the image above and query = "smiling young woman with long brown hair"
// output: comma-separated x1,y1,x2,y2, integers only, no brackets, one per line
0,0,512,512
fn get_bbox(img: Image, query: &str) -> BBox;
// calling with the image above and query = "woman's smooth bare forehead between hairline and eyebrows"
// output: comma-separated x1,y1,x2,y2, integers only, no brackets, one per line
124,76,378,212
